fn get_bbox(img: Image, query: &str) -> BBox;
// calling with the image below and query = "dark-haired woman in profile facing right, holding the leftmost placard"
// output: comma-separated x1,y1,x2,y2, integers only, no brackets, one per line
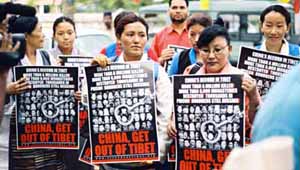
2,16,64,169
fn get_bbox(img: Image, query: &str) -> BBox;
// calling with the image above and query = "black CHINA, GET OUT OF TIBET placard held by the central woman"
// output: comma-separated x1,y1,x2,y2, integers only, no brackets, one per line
85,62,159,164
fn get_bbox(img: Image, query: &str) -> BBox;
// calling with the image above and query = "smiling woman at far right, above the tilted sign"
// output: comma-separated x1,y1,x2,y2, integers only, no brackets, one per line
256,5,300,56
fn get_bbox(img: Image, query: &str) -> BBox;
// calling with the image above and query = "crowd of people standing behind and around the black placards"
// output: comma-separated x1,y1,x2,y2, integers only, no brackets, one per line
0,0,300,170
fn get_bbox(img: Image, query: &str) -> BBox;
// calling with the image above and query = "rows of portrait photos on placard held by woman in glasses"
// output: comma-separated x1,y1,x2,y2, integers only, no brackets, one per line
176,105,242,150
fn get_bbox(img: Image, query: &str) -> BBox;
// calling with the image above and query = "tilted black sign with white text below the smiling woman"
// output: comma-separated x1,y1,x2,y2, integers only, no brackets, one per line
238,47,299,96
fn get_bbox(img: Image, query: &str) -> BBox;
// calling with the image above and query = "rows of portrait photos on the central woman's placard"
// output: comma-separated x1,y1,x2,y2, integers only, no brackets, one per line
90,88,154,133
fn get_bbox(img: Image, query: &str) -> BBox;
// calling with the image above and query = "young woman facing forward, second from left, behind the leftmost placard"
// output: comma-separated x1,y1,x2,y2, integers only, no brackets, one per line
49,16,92,170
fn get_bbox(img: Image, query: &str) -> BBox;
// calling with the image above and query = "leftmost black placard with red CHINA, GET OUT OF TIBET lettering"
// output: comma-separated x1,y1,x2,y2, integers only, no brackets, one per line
15,66,79,149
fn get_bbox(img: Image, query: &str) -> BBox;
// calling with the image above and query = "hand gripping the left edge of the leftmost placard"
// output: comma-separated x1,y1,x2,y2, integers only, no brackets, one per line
6,77,31,94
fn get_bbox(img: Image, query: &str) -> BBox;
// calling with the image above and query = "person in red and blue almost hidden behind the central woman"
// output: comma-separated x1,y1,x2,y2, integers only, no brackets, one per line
100,11,158,61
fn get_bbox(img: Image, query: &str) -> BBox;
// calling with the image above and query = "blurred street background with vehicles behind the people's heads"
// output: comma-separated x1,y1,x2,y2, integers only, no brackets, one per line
0,0,300,57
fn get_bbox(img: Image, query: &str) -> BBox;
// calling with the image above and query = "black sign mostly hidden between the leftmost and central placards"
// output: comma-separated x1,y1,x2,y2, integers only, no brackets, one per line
58,55,93,128
